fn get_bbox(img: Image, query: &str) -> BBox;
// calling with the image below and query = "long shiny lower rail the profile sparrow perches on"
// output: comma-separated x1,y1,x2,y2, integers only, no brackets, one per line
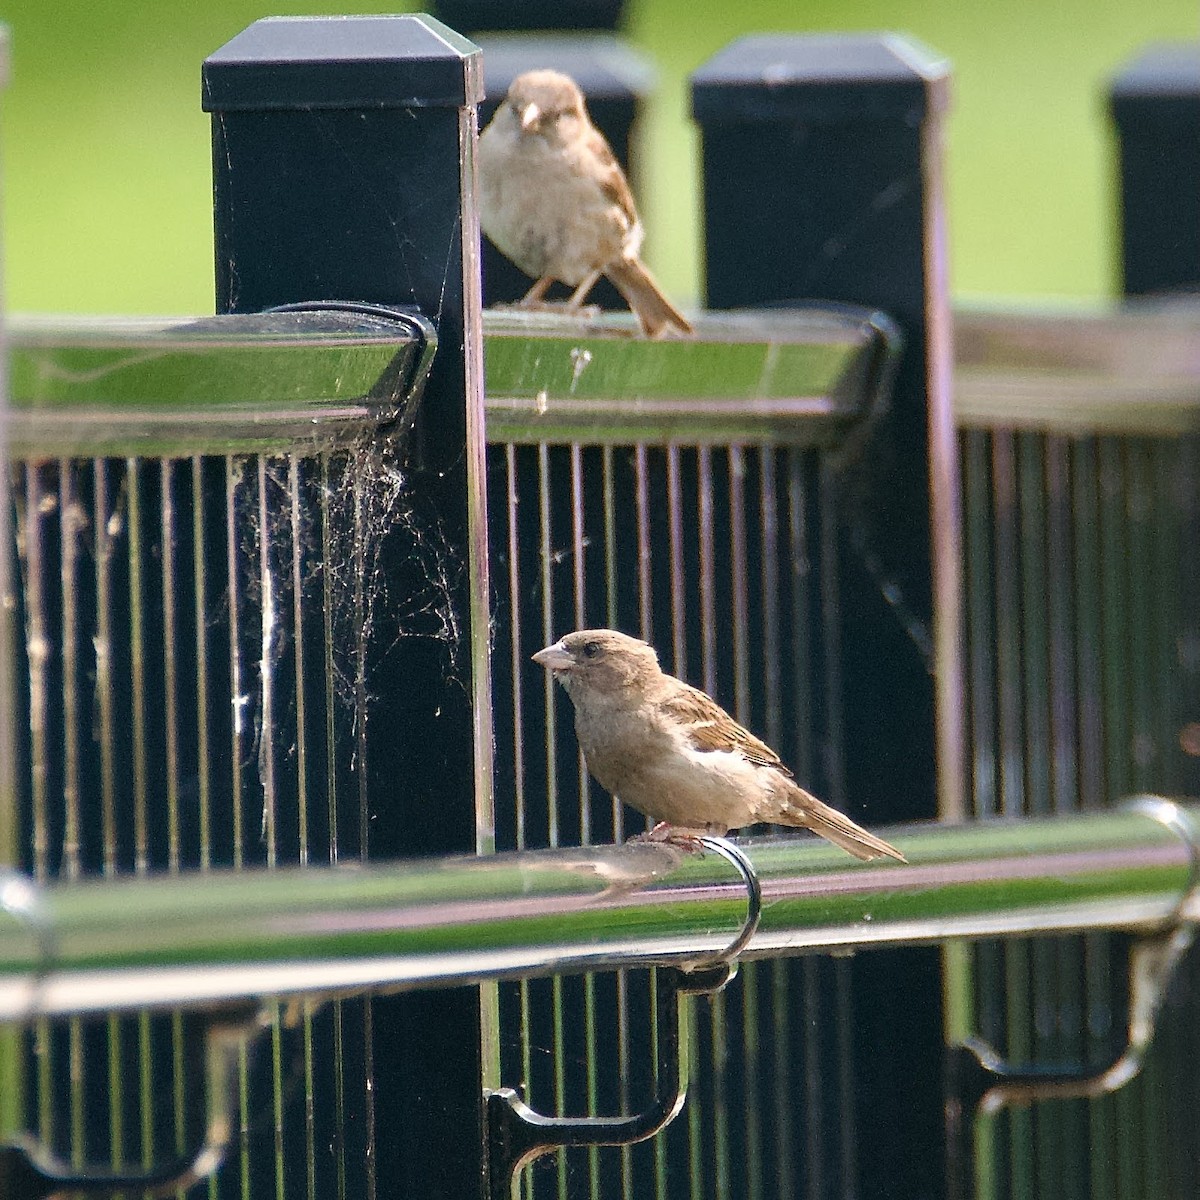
0,798,1200,1020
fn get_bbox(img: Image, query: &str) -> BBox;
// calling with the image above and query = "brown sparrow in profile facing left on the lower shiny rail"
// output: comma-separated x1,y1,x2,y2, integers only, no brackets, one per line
533,629,906,863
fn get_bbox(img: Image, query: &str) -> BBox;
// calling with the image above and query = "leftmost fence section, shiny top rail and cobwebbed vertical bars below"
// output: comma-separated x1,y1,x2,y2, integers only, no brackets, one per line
0,308,441,1200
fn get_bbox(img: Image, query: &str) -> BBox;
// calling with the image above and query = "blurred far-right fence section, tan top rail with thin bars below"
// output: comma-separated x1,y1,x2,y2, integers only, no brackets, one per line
948,295,1200,1198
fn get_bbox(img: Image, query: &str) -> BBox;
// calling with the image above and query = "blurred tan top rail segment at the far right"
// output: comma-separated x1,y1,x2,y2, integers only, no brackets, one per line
954,299,1200,437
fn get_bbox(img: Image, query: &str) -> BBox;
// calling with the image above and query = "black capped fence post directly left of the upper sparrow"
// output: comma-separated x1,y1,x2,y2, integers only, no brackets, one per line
203,16,492,1200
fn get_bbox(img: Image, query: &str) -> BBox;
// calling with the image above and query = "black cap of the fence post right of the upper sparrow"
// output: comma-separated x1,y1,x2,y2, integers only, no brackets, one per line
691,34,950,125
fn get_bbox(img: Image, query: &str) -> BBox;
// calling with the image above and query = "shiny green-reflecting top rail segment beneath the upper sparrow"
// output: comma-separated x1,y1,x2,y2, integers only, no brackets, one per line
484,304,899,445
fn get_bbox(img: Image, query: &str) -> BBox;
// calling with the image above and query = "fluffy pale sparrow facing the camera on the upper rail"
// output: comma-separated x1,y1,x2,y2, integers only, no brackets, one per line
479,71,691,337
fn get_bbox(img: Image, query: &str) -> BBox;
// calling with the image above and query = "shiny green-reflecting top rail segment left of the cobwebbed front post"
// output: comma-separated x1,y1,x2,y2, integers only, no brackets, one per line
6,306,433,458
